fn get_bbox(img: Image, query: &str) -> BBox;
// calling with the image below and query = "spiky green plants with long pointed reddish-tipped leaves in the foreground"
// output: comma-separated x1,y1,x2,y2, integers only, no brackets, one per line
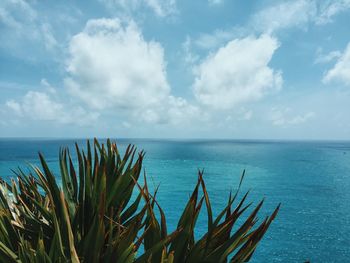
0,139,279,263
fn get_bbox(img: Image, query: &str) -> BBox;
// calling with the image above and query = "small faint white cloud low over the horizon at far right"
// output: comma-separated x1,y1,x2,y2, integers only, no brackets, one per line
270,108,315,126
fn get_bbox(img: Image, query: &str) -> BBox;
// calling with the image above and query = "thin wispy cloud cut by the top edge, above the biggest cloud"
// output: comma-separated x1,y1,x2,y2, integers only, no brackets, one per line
100,0,176,17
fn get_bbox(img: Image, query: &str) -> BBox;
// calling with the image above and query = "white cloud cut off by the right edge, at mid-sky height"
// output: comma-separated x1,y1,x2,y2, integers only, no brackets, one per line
323,43,350,86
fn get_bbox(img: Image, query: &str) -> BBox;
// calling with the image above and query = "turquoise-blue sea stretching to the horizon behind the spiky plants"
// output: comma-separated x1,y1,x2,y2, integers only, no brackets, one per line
0,139,350,262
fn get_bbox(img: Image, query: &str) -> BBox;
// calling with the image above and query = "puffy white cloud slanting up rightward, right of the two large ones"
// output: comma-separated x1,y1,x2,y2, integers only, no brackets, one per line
193,35,282,109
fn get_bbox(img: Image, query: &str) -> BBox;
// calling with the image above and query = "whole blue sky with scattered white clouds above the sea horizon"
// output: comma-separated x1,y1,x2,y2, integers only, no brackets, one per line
0,0,350,140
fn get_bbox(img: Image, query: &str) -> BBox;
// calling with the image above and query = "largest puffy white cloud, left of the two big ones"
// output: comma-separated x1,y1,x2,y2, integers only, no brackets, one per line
65,19,197,123
